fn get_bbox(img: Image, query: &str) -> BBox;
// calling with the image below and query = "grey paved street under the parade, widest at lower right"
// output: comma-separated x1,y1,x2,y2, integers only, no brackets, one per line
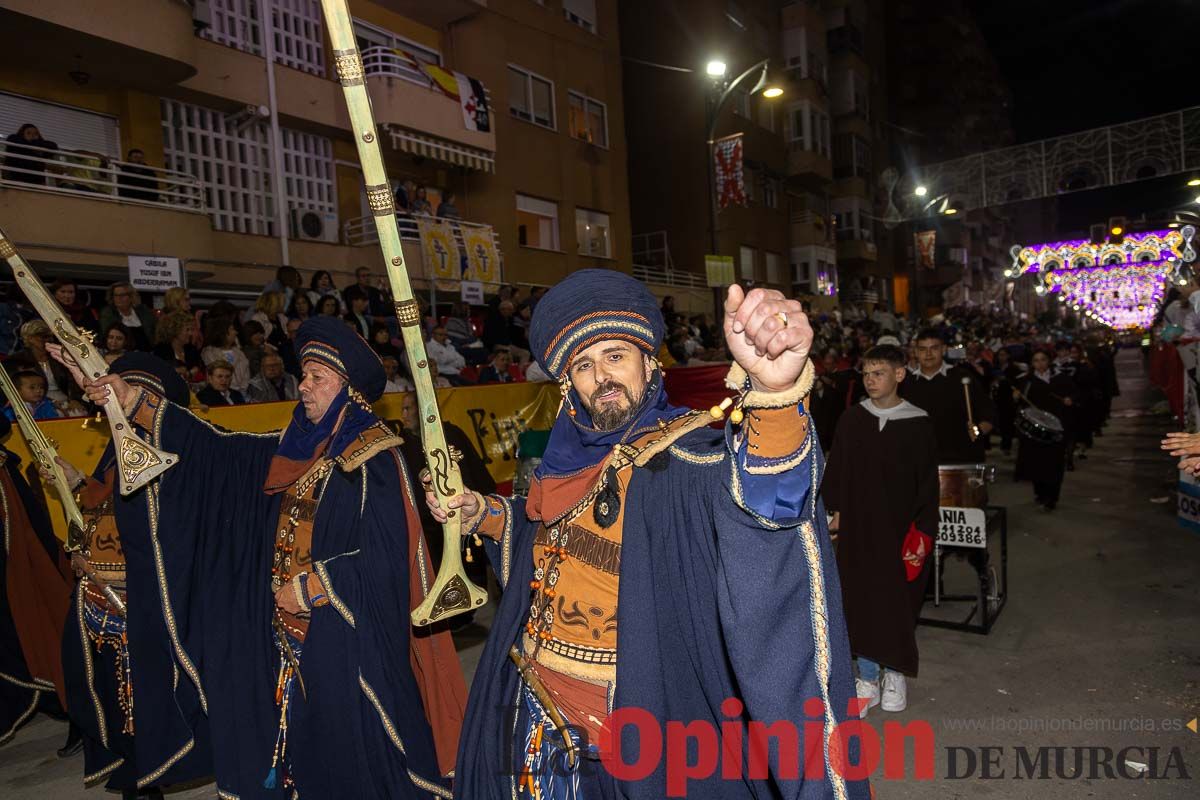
0,350,1200,800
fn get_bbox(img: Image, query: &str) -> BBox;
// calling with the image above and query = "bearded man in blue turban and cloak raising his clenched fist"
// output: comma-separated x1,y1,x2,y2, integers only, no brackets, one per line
436,270,868,800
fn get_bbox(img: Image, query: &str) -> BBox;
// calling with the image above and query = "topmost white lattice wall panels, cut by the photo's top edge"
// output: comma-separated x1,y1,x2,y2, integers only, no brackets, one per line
200,0,325,77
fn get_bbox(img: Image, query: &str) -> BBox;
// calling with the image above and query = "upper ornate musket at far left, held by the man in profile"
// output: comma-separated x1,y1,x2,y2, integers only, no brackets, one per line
0,230,179,494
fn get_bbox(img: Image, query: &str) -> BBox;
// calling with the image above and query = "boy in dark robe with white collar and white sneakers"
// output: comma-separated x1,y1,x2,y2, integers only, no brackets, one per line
821,344,938,716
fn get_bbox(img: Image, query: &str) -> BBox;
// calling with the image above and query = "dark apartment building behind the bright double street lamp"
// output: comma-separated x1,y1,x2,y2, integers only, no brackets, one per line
622,0,890,306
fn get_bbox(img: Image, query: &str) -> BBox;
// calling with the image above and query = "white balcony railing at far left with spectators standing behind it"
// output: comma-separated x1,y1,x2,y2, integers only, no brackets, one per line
0,142,206,213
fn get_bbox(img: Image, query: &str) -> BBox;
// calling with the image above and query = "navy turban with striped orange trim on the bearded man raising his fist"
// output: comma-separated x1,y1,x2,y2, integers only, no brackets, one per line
529,270,666,381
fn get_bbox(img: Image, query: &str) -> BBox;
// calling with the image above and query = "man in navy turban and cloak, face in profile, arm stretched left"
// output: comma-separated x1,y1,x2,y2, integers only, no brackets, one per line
60,317,466,800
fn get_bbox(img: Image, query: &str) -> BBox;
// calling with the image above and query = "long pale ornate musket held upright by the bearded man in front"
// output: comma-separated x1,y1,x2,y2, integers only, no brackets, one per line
320,0,487,625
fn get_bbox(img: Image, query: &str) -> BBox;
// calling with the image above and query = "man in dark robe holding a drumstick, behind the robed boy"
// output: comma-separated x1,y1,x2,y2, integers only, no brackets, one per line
900,329,996,464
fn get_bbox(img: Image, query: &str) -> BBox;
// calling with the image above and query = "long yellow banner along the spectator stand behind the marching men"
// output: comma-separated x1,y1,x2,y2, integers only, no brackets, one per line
11,383,560,540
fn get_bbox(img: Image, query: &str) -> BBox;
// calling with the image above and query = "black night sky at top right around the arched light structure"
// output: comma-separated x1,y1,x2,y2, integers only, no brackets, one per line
968,0,1200,235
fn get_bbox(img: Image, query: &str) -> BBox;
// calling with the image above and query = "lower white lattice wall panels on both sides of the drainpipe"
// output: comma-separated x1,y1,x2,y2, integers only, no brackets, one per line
162,100,337,236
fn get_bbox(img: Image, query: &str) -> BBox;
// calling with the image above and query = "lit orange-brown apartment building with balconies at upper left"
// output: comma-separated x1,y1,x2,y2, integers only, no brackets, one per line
0,0,630,296
